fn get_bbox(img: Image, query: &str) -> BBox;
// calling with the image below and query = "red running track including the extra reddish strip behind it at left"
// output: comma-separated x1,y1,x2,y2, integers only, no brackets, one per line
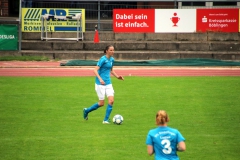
0,61,240,77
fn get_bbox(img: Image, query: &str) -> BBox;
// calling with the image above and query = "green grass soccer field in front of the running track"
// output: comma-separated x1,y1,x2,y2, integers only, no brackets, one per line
0,76,240,160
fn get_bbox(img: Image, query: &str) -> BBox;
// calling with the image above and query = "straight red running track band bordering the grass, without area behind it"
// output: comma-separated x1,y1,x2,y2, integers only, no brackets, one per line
0,67,240,77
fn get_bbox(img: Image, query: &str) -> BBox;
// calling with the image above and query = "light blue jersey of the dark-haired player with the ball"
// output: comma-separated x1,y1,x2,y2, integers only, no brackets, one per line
95,55,114,85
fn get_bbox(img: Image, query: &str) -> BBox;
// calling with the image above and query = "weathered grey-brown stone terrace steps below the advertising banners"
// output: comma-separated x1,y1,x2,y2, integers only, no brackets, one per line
0,31,240,61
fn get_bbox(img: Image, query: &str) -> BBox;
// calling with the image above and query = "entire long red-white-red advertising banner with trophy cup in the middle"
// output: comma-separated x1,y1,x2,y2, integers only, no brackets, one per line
113,8,240,33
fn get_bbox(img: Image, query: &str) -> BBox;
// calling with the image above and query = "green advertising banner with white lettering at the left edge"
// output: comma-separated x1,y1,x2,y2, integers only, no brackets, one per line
0,25,18,51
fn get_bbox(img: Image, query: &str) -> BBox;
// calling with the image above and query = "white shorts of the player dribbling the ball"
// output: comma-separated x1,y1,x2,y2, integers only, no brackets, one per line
95,83,114,100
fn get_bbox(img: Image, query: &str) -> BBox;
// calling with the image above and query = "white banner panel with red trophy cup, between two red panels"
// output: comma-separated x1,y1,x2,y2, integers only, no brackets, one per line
155,9,196,33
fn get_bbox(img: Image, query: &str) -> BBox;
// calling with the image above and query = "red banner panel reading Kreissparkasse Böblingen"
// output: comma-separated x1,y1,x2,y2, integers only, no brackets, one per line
197,9,239,32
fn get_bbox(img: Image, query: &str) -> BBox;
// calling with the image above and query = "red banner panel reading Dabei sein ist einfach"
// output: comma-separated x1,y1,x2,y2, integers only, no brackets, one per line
113,9,155,32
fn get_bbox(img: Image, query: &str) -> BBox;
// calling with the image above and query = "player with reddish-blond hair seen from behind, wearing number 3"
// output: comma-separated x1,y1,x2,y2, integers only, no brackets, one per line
146,110,186,160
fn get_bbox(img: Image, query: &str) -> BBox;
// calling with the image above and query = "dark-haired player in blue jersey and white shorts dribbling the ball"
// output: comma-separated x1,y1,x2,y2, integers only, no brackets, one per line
83,45,124,124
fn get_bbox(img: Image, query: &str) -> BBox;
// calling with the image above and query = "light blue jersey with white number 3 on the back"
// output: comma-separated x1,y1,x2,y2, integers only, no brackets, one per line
146,127,185,160
